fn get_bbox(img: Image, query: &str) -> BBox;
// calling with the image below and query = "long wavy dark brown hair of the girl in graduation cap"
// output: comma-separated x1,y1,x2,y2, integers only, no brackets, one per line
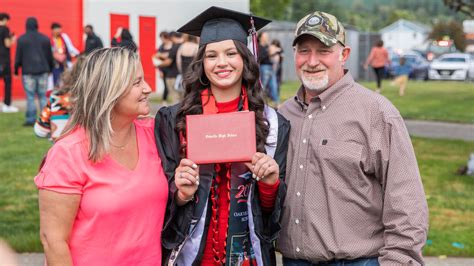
176,41,269,156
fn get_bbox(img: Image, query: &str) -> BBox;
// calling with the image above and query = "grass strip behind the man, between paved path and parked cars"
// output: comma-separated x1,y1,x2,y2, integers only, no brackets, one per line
281,80,474,123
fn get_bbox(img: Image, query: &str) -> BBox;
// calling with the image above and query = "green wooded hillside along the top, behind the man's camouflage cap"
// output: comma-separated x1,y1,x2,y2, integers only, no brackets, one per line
256,0,466,31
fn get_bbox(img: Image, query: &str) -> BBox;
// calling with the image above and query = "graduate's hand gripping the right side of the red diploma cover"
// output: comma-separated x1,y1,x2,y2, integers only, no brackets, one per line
245,152,280,185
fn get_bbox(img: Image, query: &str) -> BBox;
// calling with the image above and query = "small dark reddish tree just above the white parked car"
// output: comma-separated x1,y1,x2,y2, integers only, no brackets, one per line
428,20,466,51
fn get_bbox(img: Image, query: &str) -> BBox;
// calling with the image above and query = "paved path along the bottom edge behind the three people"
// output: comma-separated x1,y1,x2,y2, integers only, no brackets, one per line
14,253,474,266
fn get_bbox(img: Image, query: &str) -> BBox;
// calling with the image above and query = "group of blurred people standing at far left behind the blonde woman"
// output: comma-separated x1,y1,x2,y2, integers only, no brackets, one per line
0,13,103,128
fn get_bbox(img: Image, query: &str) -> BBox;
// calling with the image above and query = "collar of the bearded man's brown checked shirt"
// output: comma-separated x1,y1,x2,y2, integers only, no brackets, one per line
294,69,354,110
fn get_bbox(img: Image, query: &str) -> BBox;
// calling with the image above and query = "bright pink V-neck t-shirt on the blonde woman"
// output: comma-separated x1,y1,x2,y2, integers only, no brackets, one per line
35,119,168,266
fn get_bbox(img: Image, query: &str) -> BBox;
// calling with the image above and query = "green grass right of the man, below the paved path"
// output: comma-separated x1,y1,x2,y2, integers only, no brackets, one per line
412,137,474,257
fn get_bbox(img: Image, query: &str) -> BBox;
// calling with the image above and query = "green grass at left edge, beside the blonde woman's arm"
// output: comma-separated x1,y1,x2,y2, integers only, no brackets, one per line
0,113,51,252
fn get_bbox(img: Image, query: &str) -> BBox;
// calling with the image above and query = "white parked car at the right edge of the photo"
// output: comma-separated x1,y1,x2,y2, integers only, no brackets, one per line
428,53,474,80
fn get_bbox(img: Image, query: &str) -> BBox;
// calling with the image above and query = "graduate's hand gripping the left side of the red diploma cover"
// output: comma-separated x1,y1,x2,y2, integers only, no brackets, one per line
174,159,199,206
